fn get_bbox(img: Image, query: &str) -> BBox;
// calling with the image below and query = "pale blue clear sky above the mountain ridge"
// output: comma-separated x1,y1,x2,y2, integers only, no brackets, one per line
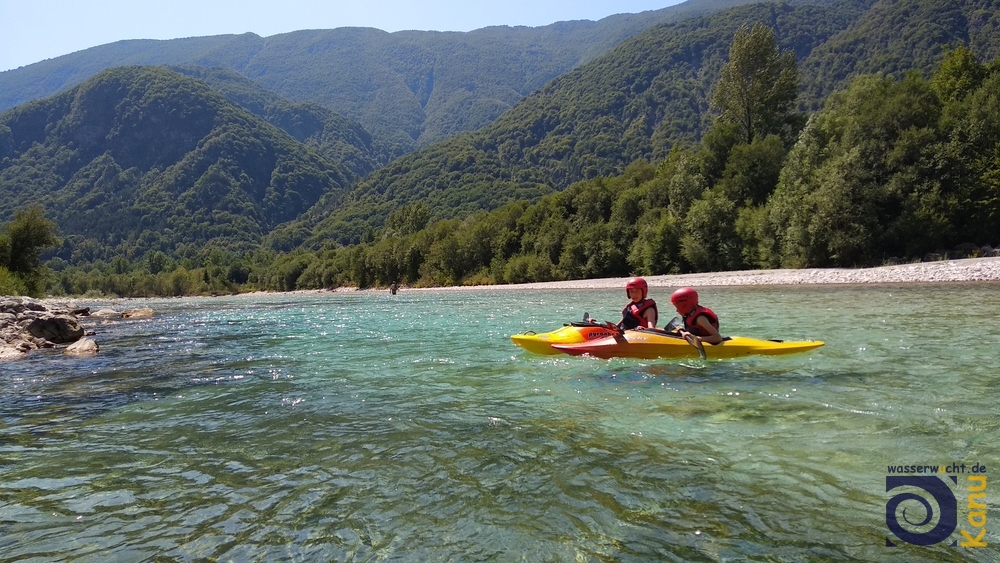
0,0,683,72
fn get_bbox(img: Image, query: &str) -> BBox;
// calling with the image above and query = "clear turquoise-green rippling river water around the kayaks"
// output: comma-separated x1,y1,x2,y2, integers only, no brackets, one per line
0,284,1000,561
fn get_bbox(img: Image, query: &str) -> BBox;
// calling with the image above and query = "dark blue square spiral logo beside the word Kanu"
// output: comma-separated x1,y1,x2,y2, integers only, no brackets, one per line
885,476,958,545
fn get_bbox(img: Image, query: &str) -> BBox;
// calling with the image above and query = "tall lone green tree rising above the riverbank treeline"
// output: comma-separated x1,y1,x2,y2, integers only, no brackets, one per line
712,23,799,143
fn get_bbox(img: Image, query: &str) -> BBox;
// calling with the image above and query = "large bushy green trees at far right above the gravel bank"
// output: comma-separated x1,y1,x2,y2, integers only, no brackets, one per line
756,61,1000,267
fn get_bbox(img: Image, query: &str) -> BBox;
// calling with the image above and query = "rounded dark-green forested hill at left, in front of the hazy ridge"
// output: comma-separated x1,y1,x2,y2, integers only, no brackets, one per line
0,67,354,255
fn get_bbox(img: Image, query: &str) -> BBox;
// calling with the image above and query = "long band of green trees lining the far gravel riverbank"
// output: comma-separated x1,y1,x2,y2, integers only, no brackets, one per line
41,44,1000,295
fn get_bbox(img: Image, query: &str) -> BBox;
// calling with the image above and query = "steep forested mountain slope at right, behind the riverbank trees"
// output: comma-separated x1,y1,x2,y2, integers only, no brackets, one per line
280,0,1000,246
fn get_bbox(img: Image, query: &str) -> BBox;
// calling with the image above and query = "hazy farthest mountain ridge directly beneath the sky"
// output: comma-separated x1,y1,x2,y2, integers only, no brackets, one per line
0,0,796,156
